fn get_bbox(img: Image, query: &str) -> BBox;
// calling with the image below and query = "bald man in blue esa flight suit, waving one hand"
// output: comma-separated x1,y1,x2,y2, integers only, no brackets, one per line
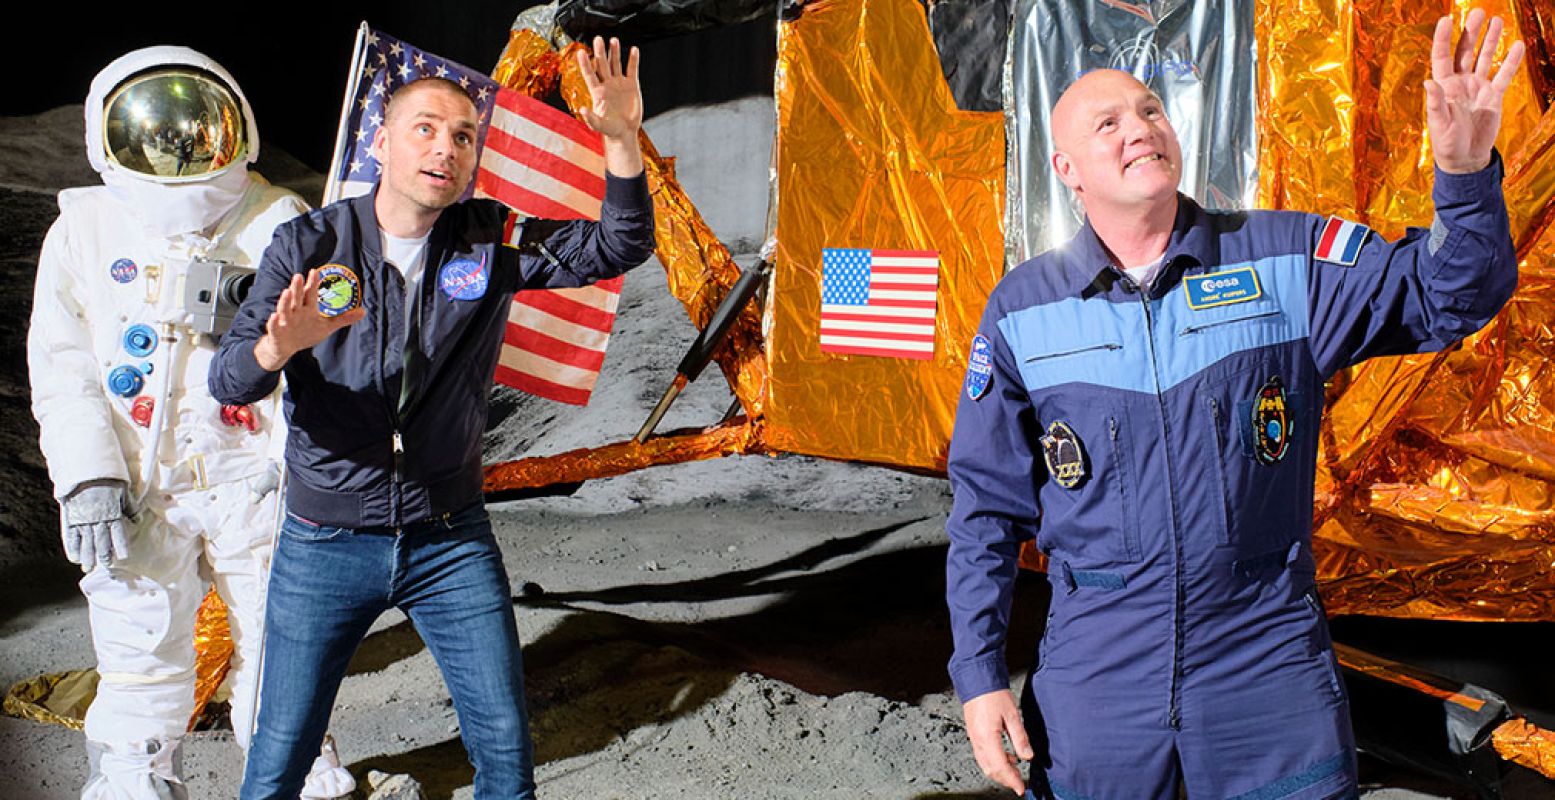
947,9,1522,800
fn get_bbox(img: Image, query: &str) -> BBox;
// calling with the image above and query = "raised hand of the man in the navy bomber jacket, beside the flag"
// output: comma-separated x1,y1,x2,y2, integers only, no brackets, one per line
577,36,642,177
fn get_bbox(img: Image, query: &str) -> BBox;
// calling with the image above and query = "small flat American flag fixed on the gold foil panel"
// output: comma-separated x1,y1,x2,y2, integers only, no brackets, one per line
821,247,939,360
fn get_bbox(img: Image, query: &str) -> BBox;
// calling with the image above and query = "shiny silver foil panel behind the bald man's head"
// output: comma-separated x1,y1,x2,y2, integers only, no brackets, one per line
1005,0,1258,266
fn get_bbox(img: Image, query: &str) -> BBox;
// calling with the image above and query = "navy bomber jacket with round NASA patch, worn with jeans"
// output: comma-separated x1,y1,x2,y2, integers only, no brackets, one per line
210,174,653,528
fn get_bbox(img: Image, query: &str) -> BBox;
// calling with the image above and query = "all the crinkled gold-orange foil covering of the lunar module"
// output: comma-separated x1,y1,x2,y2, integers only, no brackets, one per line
472,0,1555,621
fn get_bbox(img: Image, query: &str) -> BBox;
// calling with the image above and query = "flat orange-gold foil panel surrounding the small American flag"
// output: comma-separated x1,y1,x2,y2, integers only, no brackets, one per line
765,0,1005,470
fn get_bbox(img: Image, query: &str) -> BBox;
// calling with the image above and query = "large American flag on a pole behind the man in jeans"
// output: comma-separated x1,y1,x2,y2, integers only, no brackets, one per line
323,22,622,405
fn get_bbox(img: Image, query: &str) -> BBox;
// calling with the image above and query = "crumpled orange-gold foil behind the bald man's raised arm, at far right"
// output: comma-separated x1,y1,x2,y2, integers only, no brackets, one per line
1256,0,1555,621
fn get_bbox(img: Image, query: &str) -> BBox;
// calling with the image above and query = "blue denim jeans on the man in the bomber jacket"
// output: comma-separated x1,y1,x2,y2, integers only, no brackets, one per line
241,503,535,800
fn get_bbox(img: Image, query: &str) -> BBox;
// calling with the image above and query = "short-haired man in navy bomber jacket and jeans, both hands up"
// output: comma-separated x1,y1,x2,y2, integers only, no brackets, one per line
210,39,653,800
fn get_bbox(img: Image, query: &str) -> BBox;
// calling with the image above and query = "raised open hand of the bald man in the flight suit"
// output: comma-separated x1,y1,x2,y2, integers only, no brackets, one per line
1426,8,1522,174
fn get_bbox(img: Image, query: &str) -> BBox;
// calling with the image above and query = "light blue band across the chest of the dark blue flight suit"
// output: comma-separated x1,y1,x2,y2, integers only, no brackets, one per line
998,254,1309,394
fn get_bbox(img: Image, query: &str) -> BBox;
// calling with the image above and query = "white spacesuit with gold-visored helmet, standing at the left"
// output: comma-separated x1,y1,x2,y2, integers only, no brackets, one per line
26,47,355,800
